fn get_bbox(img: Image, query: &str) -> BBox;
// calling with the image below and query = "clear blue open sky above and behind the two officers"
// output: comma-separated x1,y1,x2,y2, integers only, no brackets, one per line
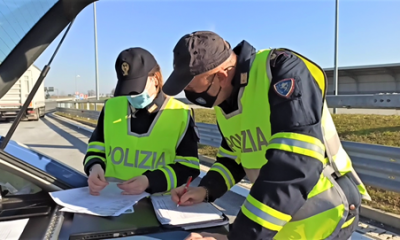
35,0,400,97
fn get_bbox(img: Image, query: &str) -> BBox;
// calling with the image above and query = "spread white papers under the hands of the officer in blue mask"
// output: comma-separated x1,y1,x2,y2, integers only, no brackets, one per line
50,183,150,216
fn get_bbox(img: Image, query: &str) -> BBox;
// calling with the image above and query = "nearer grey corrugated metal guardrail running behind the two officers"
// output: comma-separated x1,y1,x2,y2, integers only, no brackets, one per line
57,107,400,193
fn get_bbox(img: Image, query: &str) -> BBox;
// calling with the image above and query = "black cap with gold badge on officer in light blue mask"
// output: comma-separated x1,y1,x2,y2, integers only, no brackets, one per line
114,47,157,96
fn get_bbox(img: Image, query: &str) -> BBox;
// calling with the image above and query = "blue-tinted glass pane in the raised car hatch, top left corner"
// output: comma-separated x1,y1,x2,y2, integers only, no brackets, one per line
0,0,58,65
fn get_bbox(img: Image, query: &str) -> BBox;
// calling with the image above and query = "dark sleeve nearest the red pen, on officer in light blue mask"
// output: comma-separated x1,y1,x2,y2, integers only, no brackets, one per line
143,113,200,194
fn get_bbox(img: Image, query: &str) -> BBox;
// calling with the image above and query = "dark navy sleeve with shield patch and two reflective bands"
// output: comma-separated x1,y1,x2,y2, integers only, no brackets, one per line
228,51,325,240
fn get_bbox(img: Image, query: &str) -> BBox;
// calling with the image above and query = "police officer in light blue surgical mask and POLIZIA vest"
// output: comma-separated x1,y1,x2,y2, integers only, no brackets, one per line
84,48,200,195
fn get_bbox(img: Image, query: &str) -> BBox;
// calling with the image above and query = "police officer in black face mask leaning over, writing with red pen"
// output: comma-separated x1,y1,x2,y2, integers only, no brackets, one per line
163,31,369,240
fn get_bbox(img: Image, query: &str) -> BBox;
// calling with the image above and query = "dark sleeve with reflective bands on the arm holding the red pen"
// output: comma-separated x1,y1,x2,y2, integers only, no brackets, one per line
199,122,246,202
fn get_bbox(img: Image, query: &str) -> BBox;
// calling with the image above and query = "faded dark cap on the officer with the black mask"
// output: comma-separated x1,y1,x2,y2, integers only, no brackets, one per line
163,31,232,96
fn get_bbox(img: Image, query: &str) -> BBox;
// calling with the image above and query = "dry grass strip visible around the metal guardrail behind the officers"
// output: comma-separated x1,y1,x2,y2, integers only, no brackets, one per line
56,109,400,214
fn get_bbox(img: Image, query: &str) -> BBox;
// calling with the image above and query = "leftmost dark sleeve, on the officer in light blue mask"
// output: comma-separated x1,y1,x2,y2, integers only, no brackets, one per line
83,108,106,175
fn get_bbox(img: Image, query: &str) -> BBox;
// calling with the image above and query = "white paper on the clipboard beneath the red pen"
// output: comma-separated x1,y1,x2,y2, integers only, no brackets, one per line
151,196,223,225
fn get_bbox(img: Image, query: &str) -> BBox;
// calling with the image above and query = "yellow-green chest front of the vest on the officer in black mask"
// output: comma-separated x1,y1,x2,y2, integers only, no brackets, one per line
214,50,271,169
